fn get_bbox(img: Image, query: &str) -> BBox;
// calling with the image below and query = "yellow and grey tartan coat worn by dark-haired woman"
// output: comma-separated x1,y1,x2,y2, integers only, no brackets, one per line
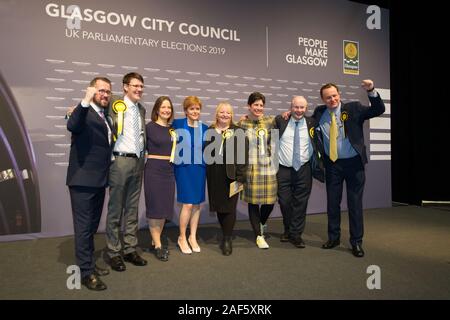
239,116,278,204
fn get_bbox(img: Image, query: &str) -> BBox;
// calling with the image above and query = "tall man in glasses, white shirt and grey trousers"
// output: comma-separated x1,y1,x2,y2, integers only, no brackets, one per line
106,72,147,271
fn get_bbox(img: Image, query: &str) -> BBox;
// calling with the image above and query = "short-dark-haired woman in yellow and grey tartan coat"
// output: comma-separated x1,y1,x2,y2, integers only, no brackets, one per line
239,92,278,249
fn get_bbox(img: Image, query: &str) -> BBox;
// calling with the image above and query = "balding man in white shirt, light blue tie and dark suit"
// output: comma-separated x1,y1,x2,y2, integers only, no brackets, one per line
275,96,323,248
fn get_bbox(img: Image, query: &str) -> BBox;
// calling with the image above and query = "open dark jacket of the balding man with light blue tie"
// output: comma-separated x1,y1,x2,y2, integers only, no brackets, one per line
275,115,325,182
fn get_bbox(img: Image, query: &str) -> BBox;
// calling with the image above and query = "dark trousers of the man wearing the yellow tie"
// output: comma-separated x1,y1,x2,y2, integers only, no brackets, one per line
324,156,366,245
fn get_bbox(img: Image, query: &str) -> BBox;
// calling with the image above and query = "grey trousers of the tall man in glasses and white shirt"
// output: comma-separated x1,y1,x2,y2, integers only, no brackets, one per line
106,156,144,258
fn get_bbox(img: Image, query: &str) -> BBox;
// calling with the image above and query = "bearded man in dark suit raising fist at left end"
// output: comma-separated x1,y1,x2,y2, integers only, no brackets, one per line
66,77,111,291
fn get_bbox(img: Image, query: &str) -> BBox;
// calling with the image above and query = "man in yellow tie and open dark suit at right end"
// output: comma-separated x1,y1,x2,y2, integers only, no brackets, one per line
313,80,385,257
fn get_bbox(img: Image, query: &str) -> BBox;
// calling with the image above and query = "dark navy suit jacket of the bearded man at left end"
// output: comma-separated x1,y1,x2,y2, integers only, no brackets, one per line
66,104,111,188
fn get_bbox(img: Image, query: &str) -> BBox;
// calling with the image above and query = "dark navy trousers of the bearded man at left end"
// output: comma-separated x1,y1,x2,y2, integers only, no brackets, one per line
69,186,105,277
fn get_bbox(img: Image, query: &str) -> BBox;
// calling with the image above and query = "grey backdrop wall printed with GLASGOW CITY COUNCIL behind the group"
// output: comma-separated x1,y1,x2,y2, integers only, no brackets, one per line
0,0,391,241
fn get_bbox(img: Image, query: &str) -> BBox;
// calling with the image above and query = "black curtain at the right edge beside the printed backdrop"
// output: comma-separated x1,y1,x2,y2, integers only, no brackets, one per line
355,1,450,205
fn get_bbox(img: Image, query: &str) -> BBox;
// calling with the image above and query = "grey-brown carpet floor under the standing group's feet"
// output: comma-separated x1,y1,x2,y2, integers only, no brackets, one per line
0,206,450,300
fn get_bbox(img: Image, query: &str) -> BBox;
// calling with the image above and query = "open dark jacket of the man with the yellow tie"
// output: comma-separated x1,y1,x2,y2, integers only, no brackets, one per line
312,94,385,164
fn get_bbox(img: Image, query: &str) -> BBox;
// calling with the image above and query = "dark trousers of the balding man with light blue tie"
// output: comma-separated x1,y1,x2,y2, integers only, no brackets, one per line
277,162,312,239
